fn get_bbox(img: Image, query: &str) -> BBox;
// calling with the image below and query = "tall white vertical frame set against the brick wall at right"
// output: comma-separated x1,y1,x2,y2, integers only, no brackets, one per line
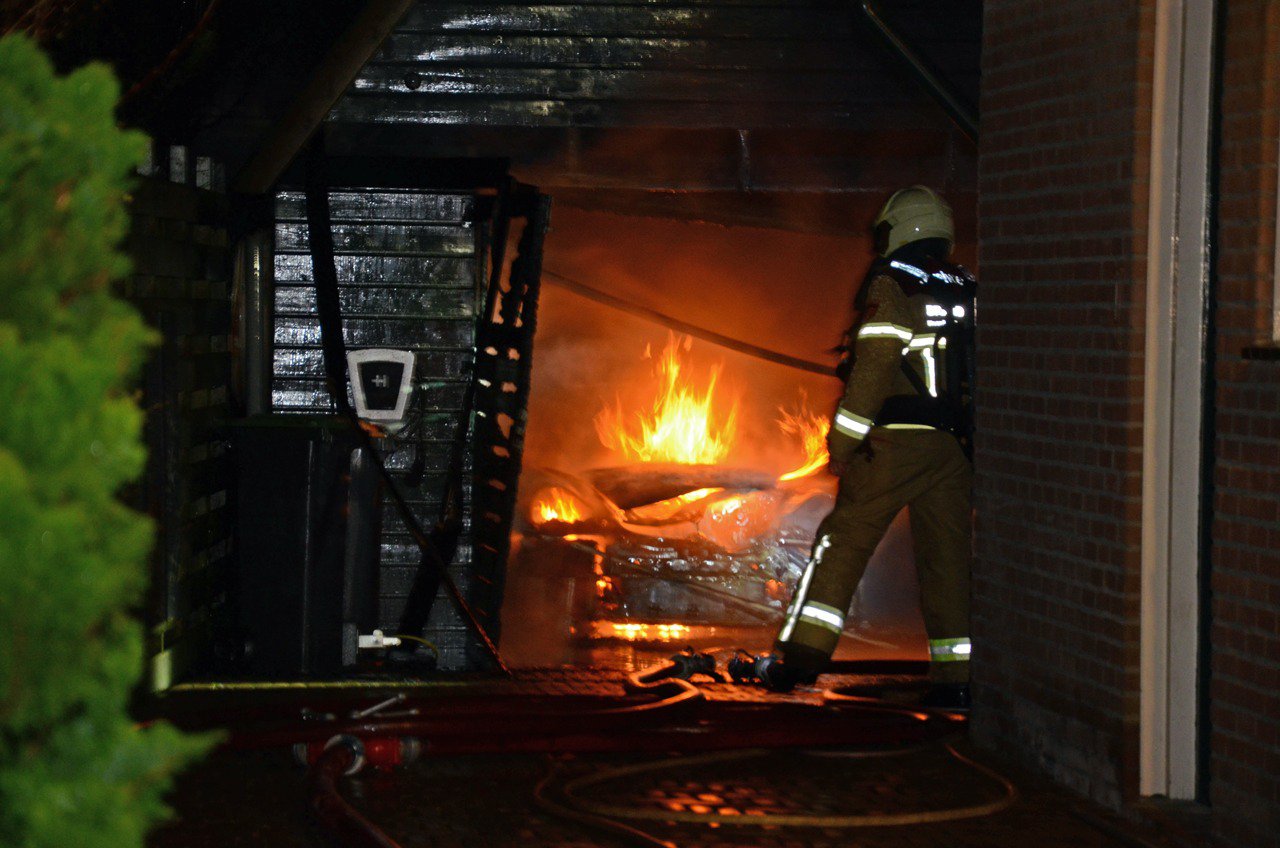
1139,0,1215,799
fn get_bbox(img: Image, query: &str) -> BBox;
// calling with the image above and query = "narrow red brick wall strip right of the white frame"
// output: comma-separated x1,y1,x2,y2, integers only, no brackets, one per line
1210,0,1280,848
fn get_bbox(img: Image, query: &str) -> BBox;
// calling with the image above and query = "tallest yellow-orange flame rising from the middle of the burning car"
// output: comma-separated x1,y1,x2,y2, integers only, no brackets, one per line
595,334,737,465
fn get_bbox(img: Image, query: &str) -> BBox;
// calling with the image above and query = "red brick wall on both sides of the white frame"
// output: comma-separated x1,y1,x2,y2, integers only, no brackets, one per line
974,0,1280,848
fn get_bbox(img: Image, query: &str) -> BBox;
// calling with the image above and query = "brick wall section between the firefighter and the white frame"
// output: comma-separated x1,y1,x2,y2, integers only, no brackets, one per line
973,0,1152,806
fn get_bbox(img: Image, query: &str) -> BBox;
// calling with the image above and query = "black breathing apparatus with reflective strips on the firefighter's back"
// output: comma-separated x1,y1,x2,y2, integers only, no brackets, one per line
836,259,978,456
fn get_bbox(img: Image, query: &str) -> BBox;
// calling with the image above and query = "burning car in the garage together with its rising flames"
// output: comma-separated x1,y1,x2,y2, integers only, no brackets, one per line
513,337,835,638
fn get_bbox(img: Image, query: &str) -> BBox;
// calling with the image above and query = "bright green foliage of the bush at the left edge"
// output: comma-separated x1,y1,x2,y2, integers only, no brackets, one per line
0,36,209,848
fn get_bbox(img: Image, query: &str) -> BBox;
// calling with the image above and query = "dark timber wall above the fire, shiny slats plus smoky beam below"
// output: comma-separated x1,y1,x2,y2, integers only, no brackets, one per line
328,0,982,235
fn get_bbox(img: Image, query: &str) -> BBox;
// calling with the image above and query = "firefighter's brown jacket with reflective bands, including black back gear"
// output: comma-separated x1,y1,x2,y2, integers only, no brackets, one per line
827,261,975,462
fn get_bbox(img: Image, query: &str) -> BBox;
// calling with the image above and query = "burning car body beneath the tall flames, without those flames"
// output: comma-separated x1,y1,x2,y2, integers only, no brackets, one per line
521,464,832,625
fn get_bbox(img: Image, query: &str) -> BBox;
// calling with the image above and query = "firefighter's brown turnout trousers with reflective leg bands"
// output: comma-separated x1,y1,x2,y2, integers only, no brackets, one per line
776,427,973,683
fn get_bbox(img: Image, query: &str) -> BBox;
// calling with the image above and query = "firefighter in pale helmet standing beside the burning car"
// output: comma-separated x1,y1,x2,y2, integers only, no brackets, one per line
754,186,975,710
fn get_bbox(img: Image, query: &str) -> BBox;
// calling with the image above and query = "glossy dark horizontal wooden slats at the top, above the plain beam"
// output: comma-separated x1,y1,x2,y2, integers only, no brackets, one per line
330,0,936,129
